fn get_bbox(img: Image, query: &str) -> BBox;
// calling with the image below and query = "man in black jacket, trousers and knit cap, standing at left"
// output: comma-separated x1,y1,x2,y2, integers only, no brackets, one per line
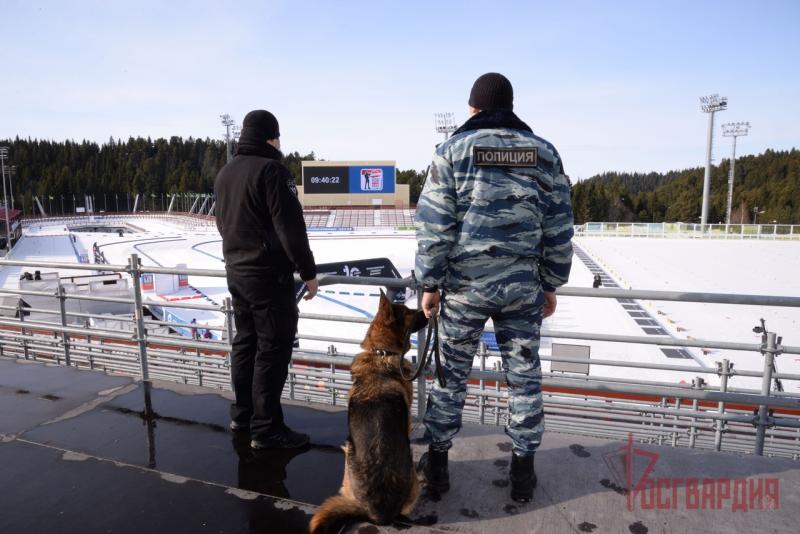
214,110,318,449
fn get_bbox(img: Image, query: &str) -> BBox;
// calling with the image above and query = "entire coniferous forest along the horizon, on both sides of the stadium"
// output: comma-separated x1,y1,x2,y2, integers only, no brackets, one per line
0,137,800,224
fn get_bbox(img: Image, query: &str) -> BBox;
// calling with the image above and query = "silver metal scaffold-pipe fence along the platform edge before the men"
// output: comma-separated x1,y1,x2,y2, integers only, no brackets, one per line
0,254,800,459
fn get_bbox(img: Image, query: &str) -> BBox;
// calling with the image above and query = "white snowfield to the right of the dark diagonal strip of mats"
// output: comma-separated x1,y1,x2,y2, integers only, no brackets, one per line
570,237,800,392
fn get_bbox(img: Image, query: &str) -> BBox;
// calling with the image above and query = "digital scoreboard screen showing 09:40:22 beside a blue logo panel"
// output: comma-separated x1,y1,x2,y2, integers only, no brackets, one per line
303,164,395,195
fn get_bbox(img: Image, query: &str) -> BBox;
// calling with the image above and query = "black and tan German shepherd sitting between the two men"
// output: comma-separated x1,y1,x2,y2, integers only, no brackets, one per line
309,291,428,534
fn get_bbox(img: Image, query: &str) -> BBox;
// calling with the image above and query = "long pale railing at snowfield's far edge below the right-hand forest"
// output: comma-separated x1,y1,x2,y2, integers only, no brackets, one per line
575,222,800,239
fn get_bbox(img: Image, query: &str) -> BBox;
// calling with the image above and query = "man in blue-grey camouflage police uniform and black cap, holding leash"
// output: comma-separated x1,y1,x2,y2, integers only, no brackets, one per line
415,73,573,502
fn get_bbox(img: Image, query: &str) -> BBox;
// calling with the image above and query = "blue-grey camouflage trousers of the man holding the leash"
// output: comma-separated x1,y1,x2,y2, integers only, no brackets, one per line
424,280,544,456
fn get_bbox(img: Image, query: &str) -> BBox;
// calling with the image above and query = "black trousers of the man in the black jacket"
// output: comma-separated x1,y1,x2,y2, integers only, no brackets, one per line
228,275,298,439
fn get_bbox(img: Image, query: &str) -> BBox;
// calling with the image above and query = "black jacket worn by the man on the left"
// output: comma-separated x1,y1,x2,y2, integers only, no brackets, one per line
214,144,317,280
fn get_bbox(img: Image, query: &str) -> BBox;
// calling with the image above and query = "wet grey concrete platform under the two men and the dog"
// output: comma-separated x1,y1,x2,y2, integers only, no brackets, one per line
0,358,800,534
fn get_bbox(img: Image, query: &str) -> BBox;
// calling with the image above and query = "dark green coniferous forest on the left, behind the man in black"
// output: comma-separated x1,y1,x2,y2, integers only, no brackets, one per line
0,137,314,215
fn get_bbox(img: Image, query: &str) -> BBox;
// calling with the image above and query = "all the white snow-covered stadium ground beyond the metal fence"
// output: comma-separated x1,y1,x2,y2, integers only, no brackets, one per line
0,219,800,392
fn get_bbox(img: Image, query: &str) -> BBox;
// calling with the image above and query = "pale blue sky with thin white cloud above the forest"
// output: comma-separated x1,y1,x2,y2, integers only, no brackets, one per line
0,0,800,178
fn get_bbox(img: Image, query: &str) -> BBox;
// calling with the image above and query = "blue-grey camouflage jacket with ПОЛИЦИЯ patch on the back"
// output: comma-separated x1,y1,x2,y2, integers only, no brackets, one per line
415,111,573,291
